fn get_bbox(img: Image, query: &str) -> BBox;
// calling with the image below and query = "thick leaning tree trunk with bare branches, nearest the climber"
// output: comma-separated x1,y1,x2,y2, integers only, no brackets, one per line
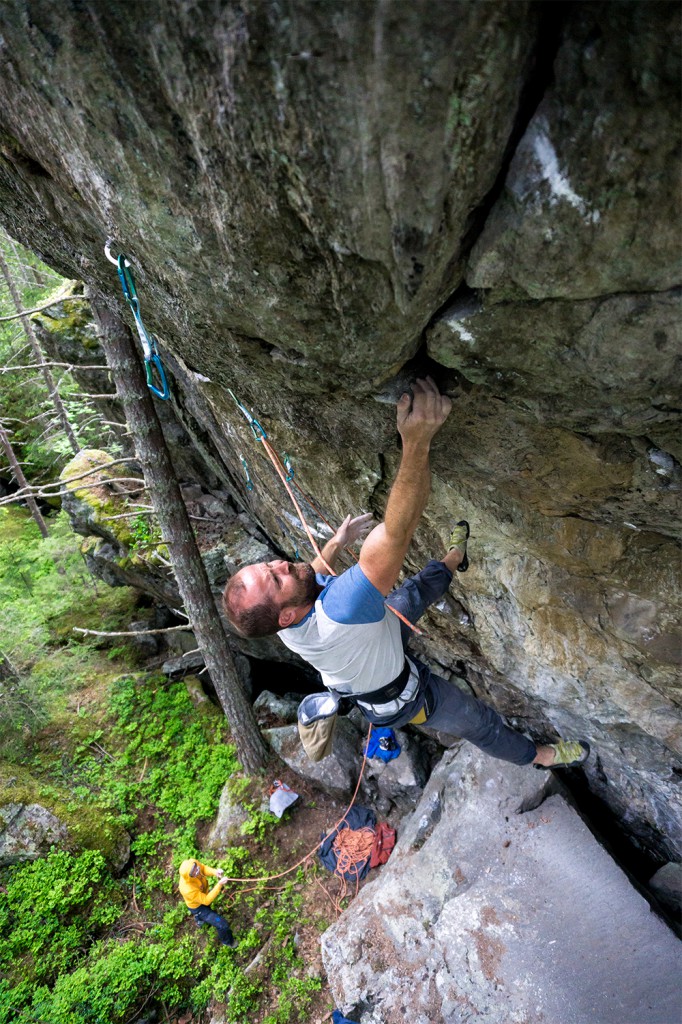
90,296,268,773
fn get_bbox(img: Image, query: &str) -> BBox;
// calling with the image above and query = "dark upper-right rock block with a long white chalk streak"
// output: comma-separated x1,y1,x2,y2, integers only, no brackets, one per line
467,3,682,301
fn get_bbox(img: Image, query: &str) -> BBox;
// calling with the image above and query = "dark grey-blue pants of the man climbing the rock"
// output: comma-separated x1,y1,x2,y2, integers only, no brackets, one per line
381,560,537,765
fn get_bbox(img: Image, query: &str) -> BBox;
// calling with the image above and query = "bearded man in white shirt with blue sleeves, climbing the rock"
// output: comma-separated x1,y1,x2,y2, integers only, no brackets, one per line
223,378,589,768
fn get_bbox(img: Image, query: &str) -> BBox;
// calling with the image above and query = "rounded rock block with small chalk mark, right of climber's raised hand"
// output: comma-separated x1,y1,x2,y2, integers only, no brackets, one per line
427,286,682,466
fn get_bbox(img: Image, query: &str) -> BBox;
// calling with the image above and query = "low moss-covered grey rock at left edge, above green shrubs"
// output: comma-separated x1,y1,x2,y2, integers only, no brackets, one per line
0,762,130,872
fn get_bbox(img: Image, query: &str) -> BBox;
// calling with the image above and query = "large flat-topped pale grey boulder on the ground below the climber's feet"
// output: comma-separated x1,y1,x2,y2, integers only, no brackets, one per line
323,748,682,1024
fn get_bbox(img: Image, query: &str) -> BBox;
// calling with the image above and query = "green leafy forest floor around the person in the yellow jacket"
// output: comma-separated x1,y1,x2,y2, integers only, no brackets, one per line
0,513,375,1024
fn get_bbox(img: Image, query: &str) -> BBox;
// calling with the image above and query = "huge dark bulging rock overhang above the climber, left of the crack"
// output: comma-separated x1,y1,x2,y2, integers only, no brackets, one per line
0,0,537,391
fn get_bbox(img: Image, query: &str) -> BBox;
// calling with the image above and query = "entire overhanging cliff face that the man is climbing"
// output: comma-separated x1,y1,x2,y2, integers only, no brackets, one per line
0,0,682,862
